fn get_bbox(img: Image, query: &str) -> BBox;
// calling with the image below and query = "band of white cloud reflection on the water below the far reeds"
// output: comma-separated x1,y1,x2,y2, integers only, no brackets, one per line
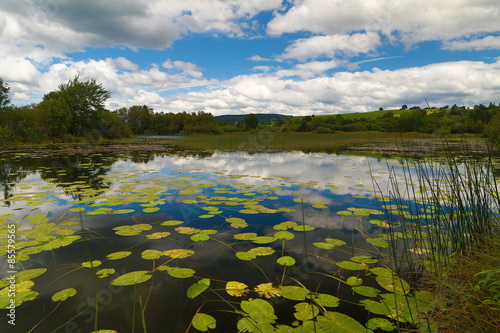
115,152,402,195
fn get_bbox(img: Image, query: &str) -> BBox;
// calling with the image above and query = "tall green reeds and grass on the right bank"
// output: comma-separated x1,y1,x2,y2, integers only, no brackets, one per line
379,142,500,332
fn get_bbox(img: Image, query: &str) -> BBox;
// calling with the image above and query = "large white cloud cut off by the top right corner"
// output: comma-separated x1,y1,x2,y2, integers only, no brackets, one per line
268,0,500,45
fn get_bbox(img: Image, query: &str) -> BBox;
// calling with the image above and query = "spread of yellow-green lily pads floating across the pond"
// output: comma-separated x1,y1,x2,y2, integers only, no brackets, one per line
0,151,460,333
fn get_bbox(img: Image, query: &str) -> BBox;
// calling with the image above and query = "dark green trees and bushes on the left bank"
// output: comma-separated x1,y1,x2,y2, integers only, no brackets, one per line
0,77,131,143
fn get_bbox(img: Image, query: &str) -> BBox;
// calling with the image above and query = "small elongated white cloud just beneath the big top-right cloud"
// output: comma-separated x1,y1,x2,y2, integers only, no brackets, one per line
280,32,380,60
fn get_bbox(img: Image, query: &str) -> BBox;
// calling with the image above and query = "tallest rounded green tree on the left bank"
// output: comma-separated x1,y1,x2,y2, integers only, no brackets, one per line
43,76,111,136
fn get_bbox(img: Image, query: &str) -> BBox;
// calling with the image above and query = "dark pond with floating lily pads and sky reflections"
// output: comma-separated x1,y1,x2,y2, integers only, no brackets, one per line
0,150,492,333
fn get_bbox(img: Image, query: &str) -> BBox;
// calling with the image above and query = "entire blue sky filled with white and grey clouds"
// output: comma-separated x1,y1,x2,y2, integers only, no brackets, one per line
0,0,500,116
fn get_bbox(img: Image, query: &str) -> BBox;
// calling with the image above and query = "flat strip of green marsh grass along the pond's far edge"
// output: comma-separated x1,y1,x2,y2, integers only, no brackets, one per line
174,132,481,153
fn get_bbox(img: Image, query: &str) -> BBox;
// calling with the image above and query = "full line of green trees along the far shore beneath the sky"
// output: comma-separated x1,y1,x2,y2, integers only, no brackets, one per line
0,76,500,143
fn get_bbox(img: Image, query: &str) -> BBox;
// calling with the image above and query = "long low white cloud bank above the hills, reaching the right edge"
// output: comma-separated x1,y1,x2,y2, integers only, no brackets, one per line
161,59,500,115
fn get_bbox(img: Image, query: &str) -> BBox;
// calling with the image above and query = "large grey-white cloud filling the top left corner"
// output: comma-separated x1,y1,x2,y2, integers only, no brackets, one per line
0,0,281,52
